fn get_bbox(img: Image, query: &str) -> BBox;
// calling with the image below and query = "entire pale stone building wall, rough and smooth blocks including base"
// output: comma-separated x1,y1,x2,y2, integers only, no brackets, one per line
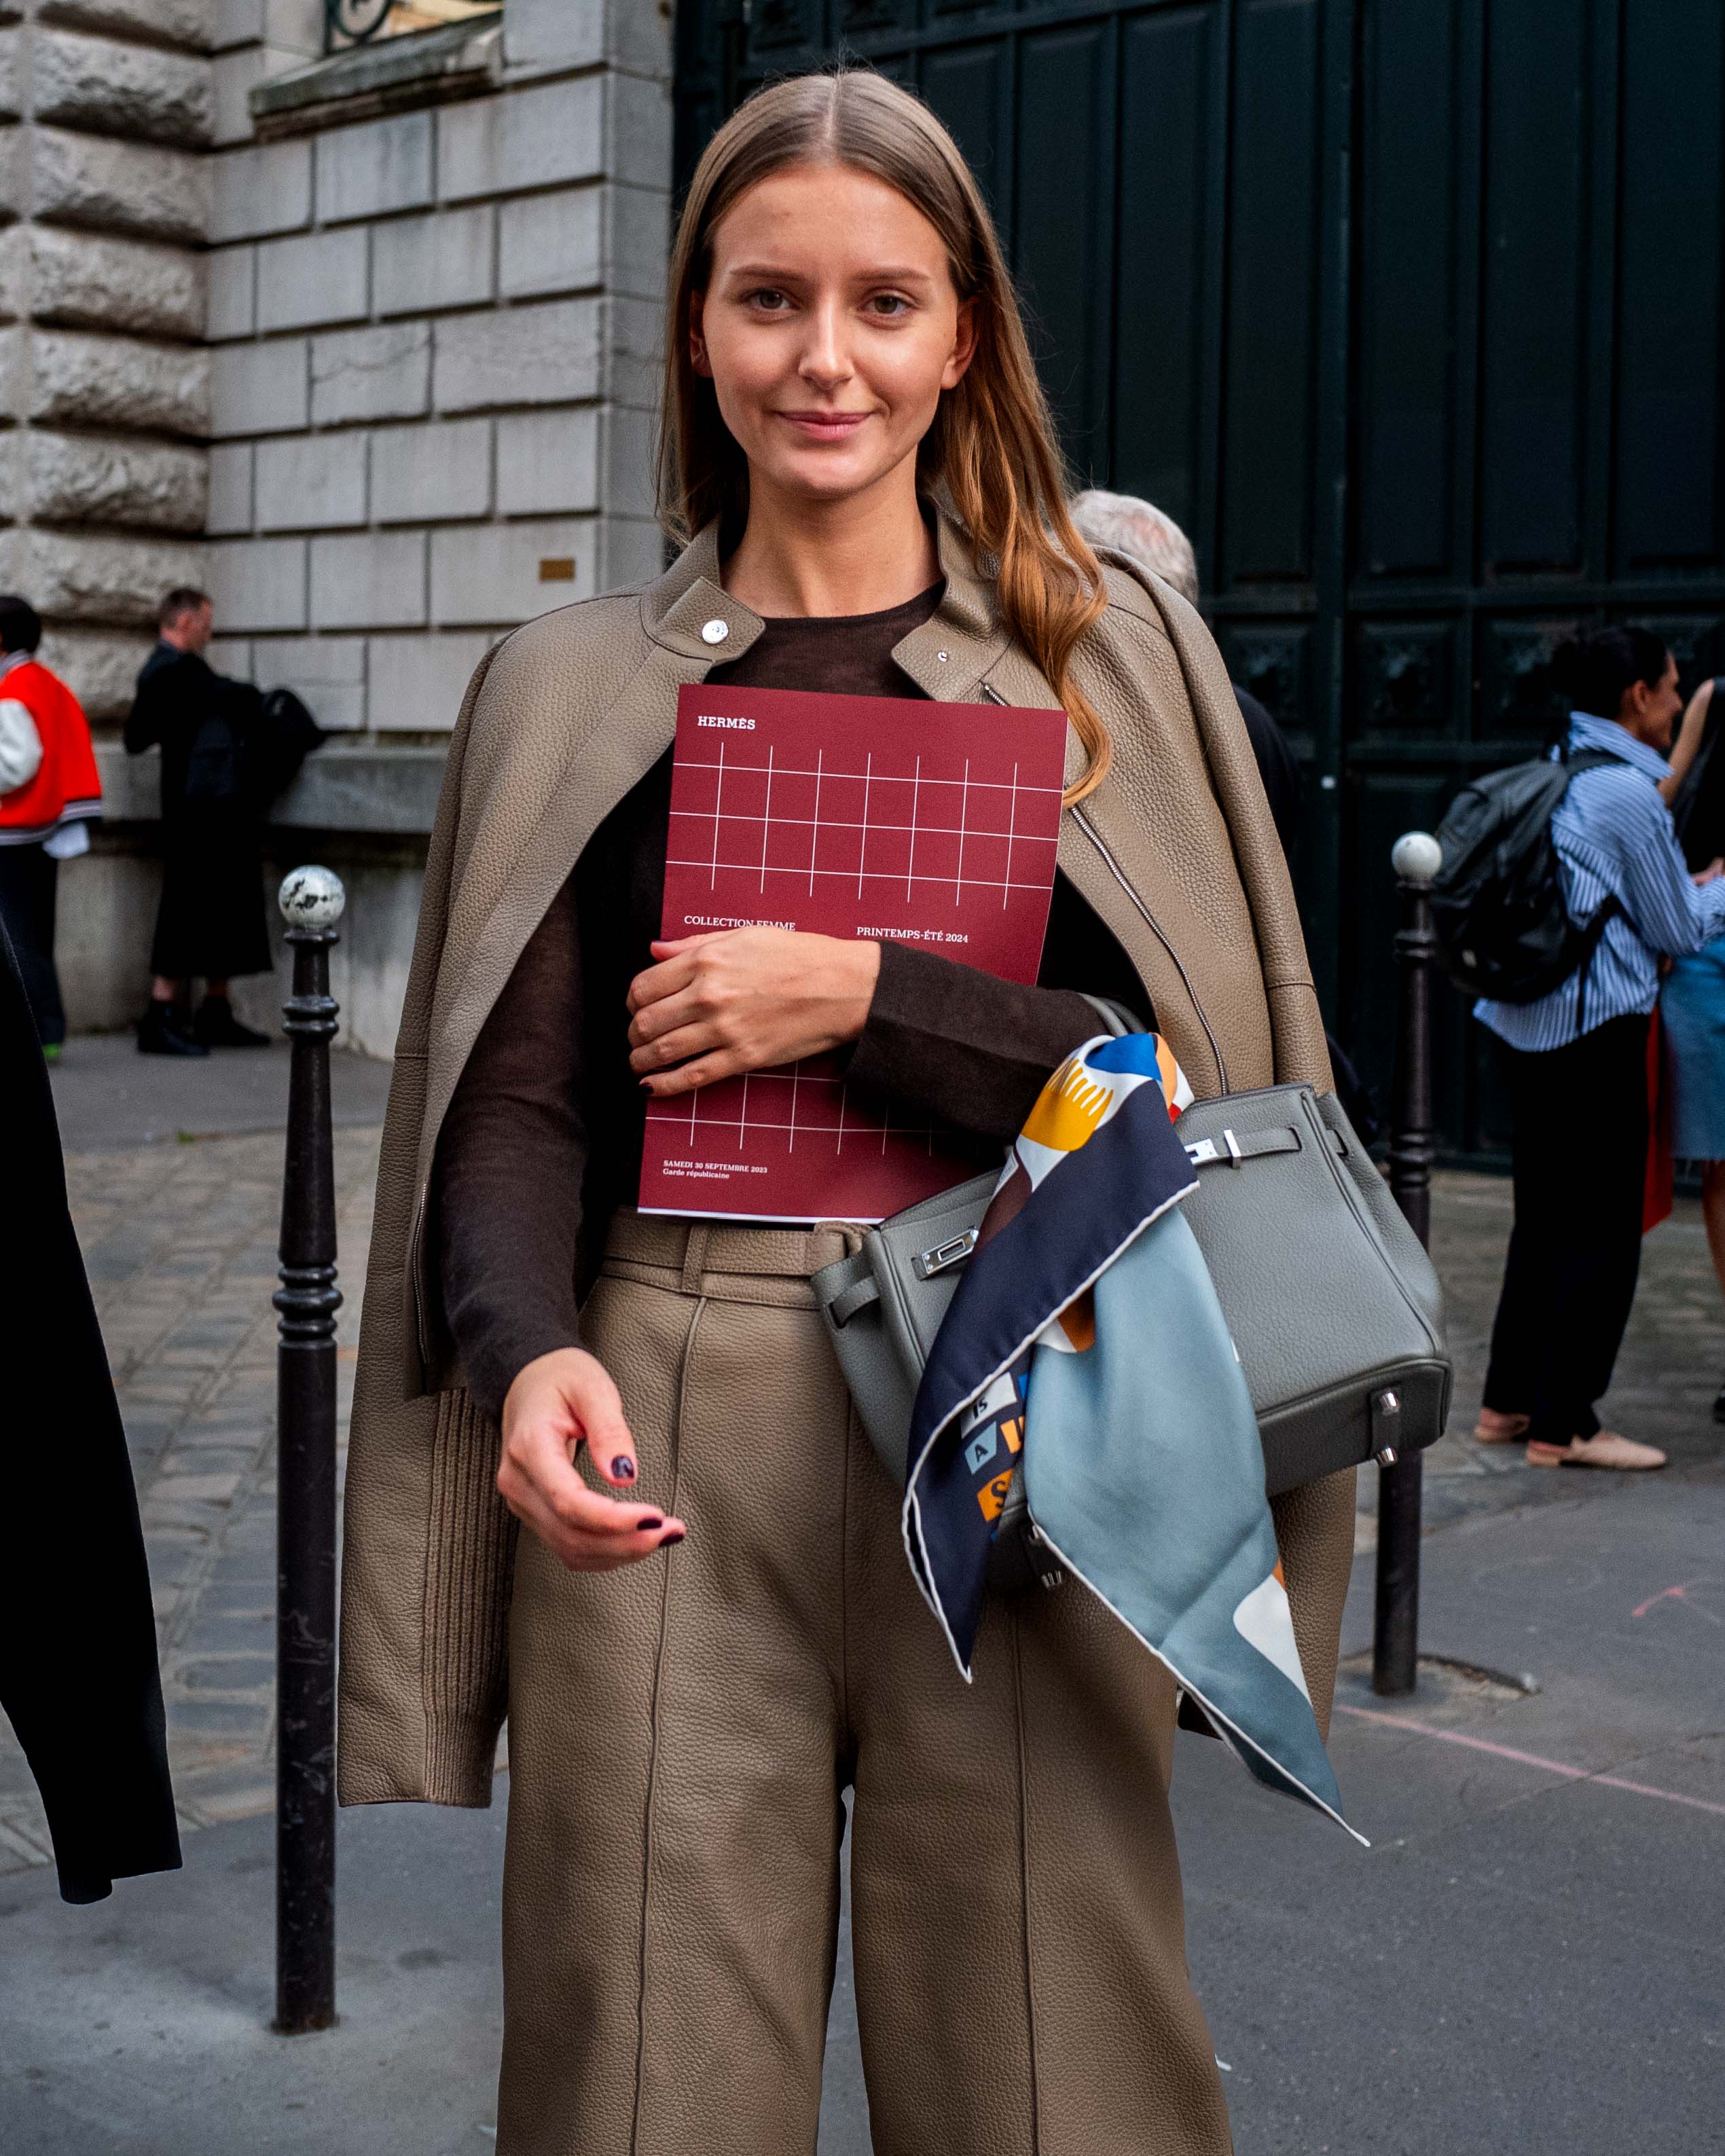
26,0,670,1055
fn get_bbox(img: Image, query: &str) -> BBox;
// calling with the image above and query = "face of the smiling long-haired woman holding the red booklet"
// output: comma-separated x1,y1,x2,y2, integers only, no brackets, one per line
690,164,975,503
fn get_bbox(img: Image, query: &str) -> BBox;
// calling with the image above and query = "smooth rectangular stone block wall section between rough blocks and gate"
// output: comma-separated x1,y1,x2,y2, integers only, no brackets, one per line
207,0,670,748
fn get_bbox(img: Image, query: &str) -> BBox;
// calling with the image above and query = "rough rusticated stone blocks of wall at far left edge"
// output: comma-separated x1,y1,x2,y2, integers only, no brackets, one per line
0,0,216,723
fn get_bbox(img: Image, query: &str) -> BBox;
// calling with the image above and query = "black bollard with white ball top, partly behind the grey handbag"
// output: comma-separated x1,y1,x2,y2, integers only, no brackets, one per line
1371,830,1442,1699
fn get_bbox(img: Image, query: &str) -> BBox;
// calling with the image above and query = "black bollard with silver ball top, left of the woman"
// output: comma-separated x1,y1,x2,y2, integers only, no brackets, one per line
274,869,347,2035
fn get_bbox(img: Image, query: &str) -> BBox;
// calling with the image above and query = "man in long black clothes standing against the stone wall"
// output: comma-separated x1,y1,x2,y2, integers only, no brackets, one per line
125,587,321,1057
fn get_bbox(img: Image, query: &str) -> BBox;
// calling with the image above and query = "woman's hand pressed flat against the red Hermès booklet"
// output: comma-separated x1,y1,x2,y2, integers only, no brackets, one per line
630,929,879,1099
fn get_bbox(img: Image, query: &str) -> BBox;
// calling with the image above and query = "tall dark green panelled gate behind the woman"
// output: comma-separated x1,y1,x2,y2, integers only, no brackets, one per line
677,0,1725,1151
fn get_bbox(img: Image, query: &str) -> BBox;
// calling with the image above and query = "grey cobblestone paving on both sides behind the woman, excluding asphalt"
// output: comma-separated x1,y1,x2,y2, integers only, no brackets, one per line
0,1130,1725,1869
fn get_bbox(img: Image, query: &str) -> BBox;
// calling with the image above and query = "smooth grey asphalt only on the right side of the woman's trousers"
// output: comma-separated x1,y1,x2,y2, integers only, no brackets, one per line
1175,1459,1725,2156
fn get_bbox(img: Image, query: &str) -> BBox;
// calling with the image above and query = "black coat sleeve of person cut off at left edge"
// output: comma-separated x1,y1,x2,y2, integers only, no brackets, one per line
0,929,179,1901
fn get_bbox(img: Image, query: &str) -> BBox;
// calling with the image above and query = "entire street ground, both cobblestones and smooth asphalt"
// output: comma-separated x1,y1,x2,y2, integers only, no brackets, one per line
0,1044,1725,2156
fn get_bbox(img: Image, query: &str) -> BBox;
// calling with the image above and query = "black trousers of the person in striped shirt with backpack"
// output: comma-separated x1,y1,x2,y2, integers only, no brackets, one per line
1486,1015,1650,1444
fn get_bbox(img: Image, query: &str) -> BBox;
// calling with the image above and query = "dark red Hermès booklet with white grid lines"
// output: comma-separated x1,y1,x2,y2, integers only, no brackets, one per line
640,686,1065,1220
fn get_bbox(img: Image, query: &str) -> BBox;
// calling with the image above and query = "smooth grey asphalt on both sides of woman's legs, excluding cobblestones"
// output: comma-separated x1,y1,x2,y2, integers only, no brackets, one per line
0,1466,1725,2156
